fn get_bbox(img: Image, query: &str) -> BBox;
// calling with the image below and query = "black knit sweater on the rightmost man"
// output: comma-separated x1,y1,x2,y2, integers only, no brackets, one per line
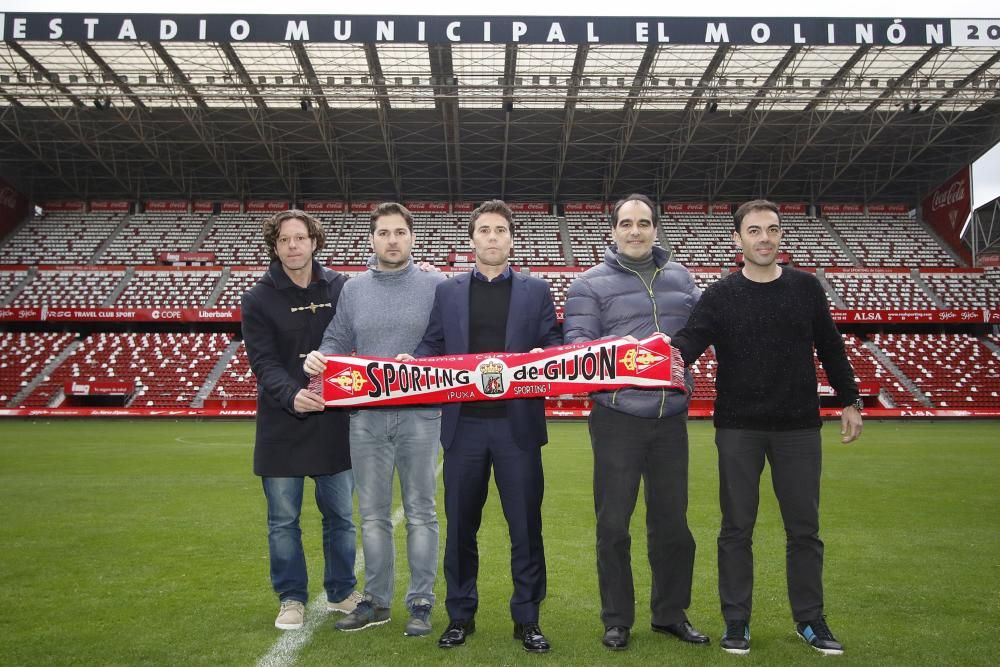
672,267,858,431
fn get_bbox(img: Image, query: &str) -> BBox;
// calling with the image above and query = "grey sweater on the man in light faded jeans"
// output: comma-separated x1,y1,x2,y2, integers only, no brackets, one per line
319,258,446,357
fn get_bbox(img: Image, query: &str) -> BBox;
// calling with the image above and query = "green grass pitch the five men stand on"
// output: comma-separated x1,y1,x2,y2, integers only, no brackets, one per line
0,421,1000,665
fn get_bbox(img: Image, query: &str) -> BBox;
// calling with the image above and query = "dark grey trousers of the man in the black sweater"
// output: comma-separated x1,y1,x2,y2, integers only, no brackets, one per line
715,428,823,621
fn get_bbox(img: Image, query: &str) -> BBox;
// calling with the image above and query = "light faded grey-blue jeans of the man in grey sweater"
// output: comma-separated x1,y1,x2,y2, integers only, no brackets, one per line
351,408,441,607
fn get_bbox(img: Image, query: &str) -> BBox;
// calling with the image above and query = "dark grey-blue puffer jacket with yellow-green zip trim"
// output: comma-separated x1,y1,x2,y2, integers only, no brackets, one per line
563,245,701,418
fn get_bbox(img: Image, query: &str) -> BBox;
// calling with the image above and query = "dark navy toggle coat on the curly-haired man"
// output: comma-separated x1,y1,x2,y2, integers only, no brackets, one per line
242,261,351,477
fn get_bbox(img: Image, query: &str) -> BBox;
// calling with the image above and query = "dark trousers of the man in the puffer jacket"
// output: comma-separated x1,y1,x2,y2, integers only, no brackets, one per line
590,404,695,627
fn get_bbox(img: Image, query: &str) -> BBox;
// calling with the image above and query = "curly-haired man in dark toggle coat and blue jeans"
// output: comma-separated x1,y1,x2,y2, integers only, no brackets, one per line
242,210,360,630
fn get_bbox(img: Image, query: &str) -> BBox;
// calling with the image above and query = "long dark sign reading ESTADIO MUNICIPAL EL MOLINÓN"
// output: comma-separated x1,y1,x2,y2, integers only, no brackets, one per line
0,12,1000,47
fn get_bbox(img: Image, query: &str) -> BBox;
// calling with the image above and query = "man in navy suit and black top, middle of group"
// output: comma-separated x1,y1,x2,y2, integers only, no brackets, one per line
398,199,562,653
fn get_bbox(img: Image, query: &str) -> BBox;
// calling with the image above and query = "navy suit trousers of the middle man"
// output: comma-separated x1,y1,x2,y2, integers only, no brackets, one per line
444,417,546,623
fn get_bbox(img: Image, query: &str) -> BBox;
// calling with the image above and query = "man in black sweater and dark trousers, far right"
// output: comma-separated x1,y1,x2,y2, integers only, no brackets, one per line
671,199,861,655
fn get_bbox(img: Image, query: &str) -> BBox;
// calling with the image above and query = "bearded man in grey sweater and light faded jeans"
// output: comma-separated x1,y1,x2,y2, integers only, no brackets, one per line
303,202,445,636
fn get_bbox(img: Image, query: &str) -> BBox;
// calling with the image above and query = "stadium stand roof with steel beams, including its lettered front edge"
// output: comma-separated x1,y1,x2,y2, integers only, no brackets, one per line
0,14,1000,204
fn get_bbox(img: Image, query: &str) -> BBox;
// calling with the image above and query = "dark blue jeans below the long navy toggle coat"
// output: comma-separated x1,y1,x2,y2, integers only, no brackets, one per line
261,470,358,604
